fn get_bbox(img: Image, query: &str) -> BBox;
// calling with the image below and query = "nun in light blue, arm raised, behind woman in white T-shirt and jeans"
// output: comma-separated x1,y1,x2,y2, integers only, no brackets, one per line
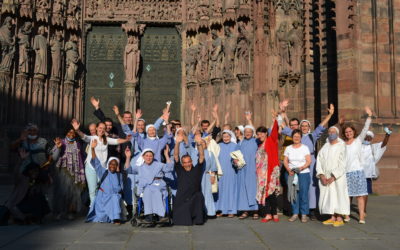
282,104,335,220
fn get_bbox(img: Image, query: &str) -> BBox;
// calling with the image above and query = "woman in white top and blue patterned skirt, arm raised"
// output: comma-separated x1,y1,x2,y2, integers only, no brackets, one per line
342,107,372,224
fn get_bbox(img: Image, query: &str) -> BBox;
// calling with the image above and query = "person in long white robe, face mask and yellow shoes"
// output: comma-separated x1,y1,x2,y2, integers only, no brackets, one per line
316,127,350,227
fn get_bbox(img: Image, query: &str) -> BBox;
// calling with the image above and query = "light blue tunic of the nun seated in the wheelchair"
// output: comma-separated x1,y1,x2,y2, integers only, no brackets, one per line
127,161,174,217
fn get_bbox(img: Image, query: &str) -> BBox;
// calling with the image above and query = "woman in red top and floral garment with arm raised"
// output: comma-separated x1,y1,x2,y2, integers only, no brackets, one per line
256,114,280,222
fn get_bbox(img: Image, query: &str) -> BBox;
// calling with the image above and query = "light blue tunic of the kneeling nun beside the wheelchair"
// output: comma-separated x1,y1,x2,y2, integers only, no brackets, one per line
86,158,122,223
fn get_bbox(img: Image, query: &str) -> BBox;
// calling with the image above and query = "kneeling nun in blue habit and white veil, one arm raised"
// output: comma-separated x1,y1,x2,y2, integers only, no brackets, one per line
86,140,123,224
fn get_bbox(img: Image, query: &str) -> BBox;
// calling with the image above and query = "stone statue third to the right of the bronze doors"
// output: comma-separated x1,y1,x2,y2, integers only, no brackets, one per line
210,30,224,79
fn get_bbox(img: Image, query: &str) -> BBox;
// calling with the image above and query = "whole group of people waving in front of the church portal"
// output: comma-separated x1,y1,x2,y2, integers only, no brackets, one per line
6,97,392,227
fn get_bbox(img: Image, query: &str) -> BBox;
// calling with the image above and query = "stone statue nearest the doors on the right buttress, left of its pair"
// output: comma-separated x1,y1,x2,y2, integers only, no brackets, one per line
276,21,290,74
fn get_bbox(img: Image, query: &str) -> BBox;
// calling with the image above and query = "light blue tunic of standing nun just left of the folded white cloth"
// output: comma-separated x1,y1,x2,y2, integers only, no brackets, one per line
217,142,237,214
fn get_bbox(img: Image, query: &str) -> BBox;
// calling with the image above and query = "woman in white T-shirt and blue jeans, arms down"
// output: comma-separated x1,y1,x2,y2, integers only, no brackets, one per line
283,129,311,222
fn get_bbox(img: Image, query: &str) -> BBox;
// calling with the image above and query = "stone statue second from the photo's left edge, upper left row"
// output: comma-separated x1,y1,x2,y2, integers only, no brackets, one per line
18,22,32,74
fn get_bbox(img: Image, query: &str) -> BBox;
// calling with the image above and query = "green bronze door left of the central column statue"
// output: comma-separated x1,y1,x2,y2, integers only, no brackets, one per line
84,26,126,124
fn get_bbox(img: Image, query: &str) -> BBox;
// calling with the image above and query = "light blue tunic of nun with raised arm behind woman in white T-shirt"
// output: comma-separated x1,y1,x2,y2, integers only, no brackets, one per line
282,125,326,209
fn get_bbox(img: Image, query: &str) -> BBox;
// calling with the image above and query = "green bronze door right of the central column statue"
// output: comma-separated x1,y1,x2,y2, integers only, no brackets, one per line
139,27,181,123
